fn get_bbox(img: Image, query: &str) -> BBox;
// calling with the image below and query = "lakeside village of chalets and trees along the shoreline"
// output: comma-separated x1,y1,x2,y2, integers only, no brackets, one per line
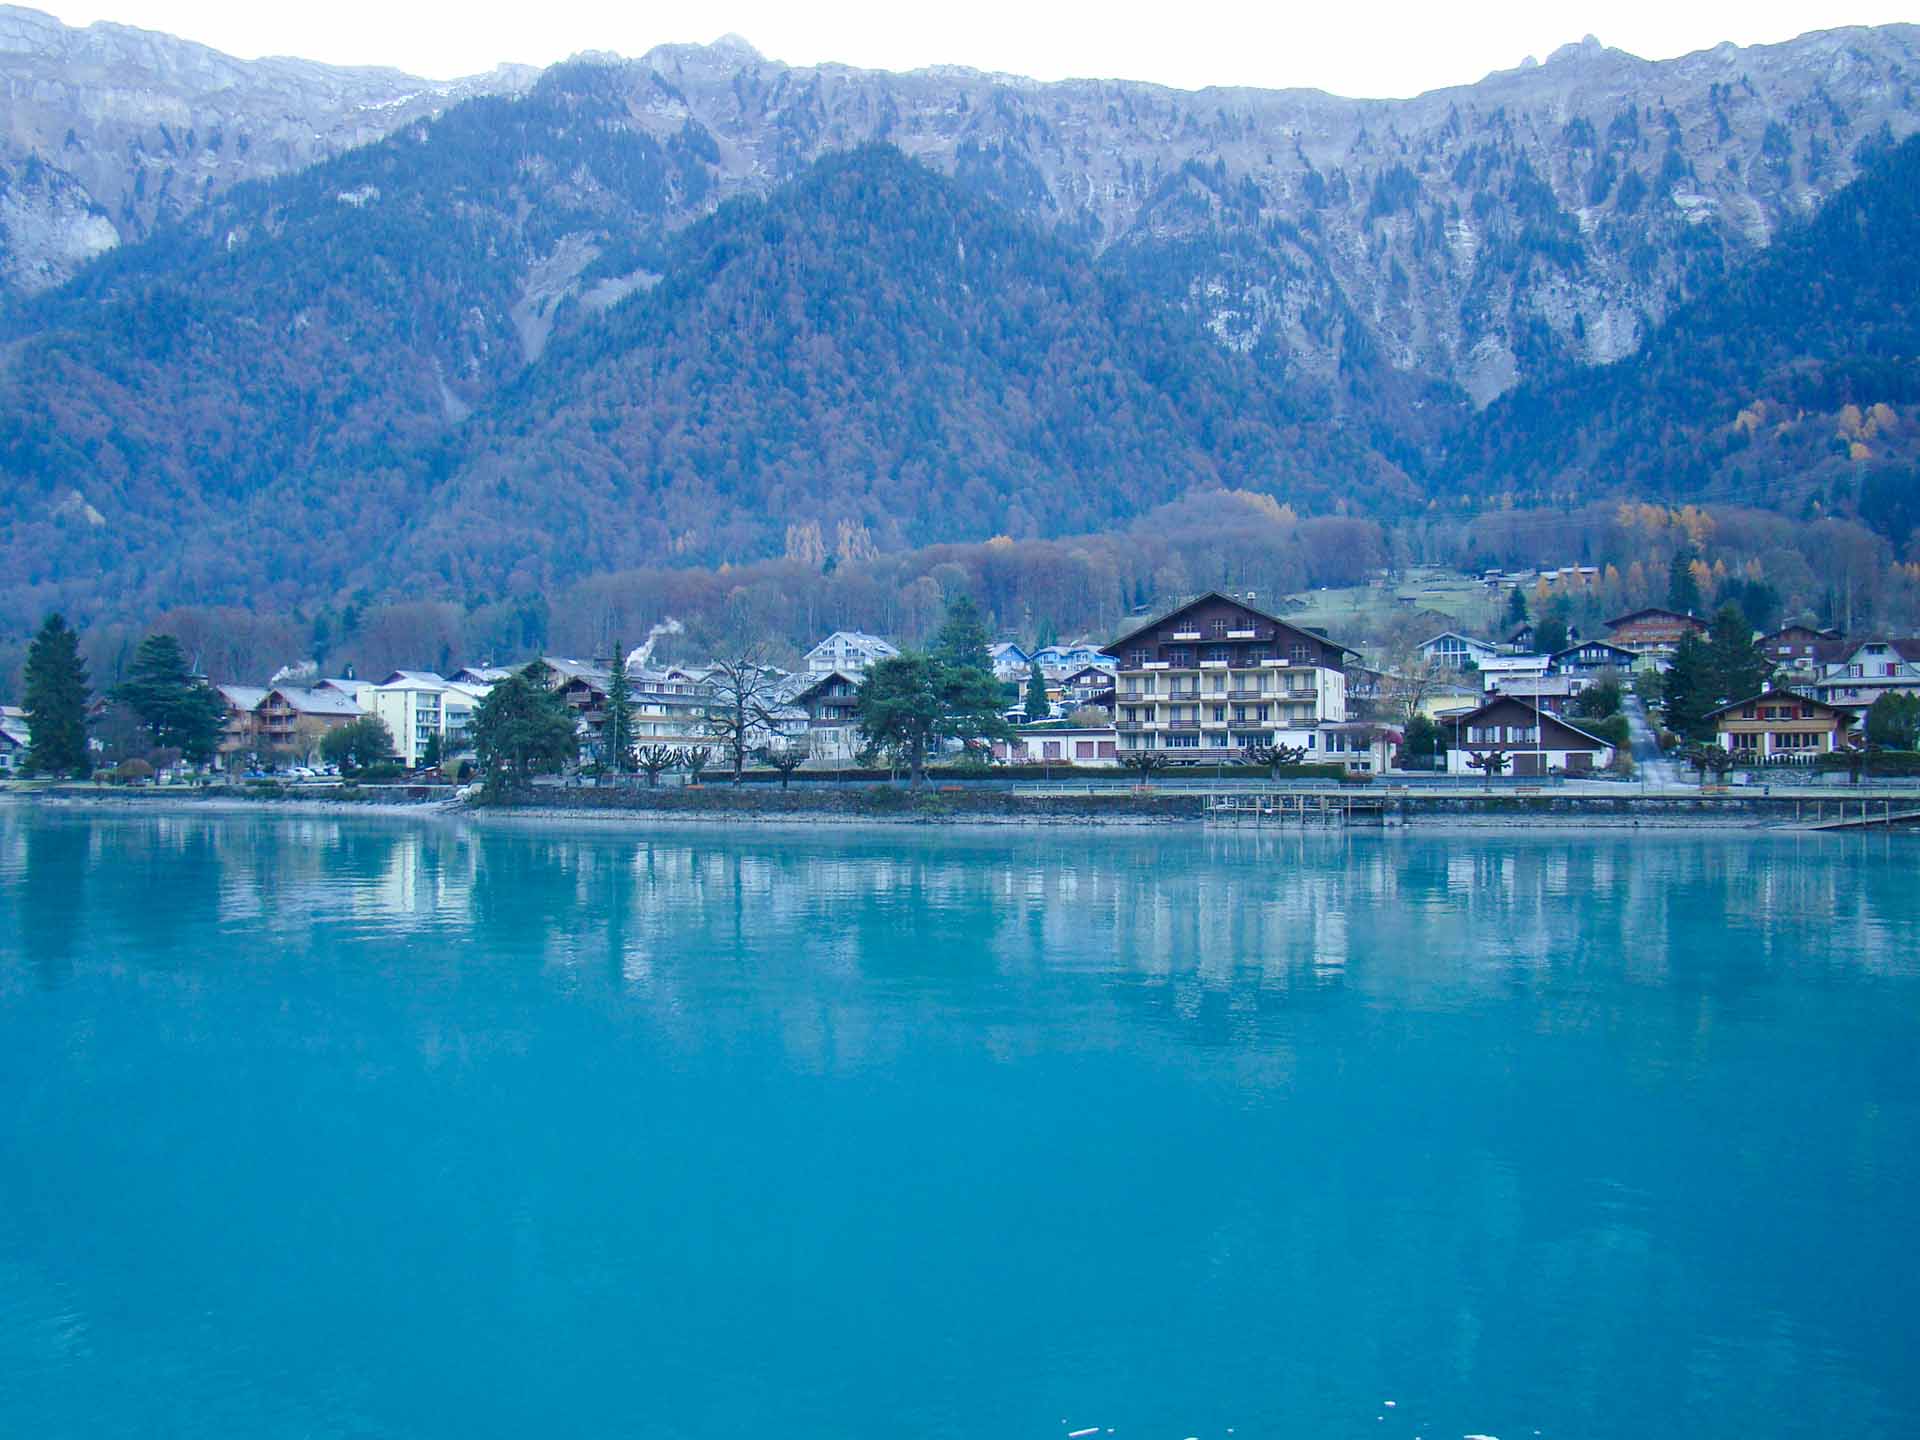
15,574,1920,826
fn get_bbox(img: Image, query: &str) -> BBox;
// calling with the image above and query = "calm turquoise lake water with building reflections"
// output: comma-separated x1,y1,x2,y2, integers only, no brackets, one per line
0,804,1920,1440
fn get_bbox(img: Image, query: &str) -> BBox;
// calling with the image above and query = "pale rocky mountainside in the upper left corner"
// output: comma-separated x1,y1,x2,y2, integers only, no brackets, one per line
0,6,538,294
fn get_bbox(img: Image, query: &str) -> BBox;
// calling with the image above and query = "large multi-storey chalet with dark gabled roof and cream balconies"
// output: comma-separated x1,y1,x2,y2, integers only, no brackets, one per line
1104,591,1354,758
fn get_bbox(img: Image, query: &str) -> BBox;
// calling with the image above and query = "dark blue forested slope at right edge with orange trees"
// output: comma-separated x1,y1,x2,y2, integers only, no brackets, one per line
1440,136,1920,547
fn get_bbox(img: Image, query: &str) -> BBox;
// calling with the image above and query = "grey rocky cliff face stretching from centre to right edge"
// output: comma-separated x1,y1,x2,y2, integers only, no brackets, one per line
595,25,1920,405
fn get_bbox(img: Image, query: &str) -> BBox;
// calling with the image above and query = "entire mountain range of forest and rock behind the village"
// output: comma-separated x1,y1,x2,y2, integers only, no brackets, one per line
0,10,1920,628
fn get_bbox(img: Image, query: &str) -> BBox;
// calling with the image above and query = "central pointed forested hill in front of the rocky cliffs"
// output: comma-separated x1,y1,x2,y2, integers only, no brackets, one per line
397,146,1415,588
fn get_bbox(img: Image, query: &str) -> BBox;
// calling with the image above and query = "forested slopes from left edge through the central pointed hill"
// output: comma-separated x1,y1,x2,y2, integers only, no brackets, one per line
0,138,1413,622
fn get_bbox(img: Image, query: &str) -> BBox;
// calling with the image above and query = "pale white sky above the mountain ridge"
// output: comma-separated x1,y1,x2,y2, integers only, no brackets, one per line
29,0,1920,96
